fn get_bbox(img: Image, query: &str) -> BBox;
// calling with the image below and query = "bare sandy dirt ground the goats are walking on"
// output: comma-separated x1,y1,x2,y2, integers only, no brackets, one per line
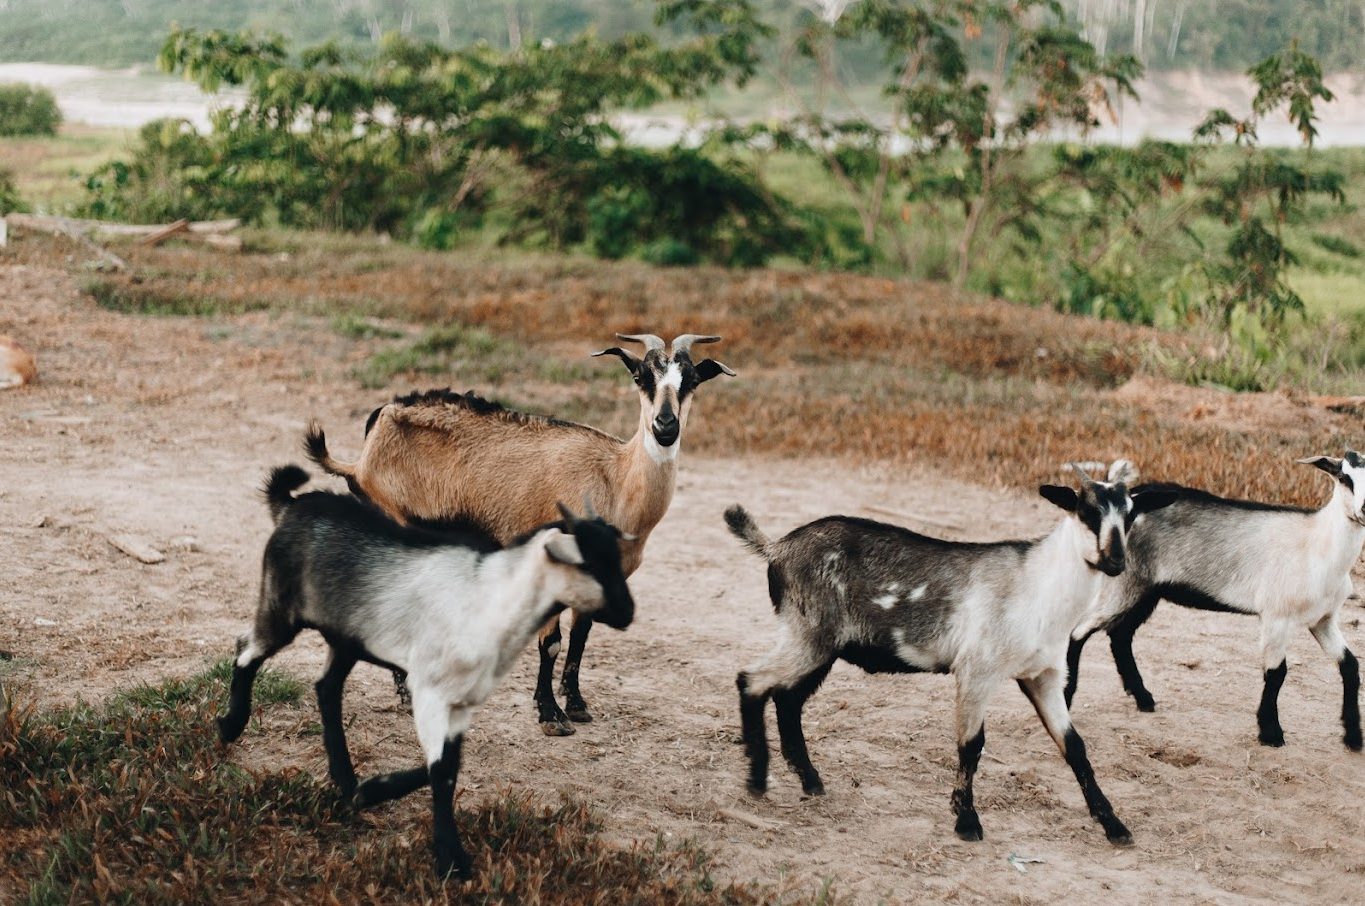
0,265,1365,906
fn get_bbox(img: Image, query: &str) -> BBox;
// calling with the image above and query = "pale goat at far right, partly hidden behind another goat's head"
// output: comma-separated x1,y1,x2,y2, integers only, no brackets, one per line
1066,450,1365,752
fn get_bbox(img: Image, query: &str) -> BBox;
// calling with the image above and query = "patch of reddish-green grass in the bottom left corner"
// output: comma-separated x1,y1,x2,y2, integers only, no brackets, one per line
0,663,829,906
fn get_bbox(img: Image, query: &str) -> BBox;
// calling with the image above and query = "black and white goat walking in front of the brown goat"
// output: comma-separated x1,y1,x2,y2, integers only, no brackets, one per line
218,465,635,877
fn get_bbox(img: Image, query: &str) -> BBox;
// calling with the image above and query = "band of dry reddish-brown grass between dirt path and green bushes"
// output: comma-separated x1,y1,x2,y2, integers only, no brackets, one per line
19,226,1360,505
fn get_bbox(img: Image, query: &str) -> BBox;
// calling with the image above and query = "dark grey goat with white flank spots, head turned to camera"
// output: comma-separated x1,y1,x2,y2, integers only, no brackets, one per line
725,469,1171,845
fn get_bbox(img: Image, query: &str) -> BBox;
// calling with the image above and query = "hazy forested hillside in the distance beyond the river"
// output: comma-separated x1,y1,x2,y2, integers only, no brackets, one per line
0,0,1365,71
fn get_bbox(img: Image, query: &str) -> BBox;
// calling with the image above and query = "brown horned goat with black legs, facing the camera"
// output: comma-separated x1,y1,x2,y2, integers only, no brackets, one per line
306,334,734,735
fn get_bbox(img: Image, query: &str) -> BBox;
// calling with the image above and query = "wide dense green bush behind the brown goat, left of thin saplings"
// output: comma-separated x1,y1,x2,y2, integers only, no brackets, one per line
86,15,801,266
